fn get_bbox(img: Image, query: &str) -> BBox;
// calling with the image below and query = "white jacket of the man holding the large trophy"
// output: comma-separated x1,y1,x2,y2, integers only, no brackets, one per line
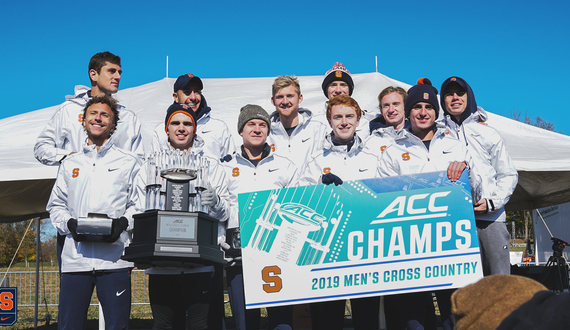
137,135,230,275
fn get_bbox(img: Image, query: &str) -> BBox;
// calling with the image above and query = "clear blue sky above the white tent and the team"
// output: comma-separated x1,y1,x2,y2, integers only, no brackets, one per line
0,0,570,134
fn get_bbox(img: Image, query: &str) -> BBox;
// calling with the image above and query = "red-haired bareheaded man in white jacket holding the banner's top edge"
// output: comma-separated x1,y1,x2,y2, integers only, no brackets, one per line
299,94,380,330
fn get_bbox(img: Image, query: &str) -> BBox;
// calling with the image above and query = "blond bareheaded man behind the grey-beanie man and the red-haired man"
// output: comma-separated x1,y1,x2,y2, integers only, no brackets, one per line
267,76,327,168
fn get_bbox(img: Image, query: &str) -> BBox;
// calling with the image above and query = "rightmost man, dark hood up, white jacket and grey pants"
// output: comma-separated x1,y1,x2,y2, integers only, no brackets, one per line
440,77,518,275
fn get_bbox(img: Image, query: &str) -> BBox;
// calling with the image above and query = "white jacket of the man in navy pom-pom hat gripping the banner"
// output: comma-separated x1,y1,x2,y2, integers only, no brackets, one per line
380,126,469,177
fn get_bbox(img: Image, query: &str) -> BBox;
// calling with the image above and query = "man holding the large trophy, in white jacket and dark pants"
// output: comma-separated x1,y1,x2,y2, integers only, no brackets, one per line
145,103,230,329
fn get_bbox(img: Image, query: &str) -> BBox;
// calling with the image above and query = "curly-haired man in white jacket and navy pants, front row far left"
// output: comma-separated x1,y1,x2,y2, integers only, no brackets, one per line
47,96,142,329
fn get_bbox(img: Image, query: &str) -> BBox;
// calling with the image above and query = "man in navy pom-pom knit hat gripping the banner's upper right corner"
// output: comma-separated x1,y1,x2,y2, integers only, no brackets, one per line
380,79,470,329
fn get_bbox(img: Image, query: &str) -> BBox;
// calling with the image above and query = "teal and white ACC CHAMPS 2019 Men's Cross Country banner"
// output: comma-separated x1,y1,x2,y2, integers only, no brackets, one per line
238,171,483,308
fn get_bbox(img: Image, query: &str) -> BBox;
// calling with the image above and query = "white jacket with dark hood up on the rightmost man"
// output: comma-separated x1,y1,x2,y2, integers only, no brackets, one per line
440,77,518,221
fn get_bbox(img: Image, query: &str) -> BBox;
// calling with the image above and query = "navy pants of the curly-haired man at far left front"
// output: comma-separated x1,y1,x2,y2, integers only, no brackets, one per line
57,270,131,330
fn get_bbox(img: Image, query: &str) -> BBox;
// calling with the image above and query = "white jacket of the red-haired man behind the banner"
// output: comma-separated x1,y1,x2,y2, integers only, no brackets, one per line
299,134,380,186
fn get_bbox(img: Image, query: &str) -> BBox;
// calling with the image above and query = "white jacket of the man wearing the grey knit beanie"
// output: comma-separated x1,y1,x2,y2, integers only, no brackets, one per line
223,144,299,228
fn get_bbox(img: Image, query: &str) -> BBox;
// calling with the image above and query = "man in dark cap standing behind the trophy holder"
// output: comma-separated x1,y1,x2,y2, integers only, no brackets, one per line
152,73,235,159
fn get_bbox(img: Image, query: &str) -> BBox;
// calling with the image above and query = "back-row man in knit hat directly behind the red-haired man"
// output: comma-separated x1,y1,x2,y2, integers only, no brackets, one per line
315,62,370,138
